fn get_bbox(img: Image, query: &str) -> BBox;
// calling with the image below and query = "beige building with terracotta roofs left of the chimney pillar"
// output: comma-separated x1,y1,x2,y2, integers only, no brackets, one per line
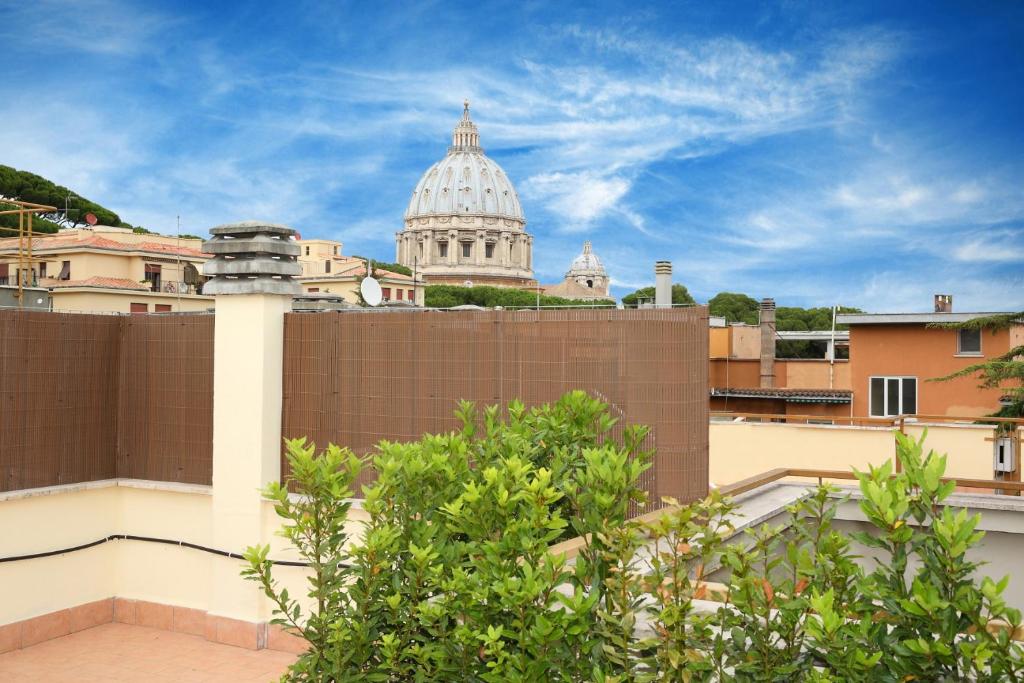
0,225,213,313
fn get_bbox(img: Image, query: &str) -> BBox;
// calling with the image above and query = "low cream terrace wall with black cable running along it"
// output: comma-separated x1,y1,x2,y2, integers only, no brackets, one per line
0,479,365,626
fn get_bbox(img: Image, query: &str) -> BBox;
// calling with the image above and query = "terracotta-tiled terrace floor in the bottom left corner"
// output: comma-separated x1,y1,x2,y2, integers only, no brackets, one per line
0,624,295,683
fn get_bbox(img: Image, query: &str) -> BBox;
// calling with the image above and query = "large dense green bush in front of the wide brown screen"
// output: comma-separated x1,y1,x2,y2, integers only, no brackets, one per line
245,391,650,681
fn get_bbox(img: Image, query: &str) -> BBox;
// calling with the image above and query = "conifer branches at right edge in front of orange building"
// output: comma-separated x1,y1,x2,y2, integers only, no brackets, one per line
928,311,1024,418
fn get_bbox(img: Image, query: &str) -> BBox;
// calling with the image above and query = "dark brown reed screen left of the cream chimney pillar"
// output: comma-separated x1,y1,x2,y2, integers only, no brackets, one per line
0,310,213,490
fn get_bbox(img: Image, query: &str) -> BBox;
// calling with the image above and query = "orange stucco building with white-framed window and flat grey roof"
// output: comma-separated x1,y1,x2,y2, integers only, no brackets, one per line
838,312,1024,417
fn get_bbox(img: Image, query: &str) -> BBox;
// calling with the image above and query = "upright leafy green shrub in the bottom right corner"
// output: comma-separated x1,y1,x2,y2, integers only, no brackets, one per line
822,433,1024,681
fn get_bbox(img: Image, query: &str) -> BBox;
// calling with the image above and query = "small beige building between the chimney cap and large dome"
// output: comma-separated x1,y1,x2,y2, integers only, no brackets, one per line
296,240,423,306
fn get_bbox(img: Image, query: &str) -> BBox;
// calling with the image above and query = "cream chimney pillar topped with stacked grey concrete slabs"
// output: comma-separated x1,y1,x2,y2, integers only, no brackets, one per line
197,221,301,623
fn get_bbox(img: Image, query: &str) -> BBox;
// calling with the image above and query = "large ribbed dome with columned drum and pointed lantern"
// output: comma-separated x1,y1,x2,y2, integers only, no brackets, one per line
395,101,536,287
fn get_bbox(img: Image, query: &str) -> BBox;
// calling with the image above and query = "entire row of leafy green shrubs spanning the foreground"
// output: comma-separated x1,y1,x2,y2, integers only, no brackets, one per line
245,401,1024,682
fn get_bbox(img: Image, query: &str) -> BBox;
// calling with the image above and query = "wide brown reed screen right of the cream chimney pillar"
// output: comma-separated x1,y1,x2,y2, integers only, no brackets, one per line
282,307,709,501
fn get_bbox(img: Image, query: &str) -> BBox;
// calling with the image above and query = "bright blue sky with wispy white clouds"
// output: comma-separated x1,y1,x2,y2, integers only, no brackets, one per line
0,0,1024,311
